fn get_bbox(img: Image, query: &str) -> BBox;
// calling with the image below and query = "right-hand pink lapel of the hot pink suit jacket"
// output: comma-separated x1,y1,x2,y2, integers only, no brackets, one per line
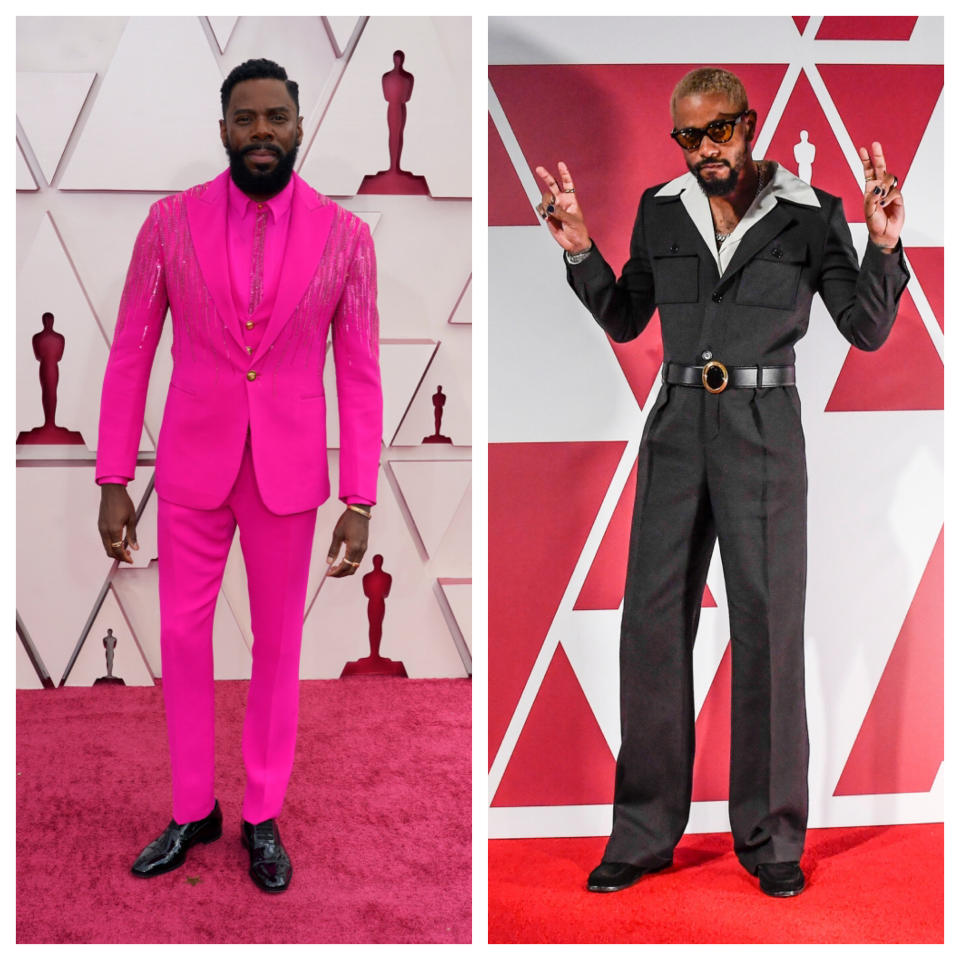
253,174,336,362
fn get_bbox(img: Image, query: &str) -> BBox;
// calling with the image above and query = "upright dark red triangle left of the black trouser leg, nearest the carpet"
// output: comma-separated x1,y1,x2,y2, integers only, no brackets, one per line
492,644,616,807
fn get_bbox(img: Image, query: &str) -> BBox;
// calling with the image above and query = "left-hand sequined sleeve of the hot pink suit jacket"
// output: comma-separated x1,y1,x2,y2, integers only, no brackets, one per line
96,205,167,481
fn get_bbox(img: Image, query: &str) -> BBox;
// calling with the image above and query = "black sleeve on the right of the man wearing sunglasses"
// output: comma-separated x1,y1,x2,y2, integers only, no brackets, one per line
818,191,910,350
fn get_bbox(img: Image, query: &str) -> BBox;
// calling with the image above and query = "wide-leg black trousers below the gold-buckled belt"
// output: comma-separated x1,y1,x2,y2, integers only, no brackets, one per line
604,385,808,873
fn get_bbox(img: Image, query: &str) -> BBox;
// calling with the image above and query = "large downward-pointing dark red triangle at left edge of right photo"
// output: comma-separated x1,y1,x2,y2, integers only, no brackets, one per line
488,441,626,762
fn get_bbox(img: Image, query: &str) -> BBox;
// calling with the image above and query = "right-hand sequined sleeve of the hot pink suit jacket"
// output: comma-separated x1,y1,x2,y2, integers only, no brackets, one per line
332,221,383,504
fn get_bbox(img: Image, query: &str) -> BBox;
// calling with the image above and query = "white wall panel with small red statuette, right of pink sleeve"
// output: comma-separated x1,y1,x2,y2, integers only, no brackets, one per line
393,338,473,447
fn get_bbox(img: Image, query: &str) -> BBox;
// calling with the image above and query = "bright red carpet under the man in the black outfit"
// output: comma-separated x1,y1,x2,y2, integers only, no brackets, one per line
488,823,943,943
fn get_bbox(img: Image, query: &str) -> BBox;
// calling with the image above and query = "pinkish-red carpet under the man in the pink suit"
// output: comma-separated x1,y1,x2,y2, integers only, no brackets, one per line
17,678,471,943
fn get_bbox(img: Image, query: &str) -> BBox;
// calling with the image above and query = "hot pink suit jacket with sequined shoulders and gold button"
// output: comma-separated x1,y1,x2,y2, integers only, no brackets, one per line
97,171,383,514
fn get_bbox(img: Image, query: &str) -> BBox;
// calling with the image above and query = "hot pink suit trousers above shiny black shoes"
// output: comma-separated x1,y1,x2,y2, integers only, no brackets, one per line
157,444,317,823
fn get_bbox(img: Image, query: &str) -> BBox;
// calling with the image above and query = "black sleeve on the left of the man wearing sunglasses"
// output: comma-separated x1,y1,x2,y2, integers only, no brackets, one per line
564,191,656,343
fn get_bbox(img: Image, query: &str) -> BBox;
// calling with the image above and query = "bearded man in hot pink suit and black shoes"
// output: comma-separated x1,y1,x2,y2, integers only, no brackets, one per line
97,60,382,891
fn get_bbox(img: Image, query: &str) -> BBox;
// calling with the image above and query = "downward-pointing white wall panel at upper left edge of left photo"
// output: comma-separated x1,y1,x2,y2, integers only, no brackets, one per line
17,71,96,183
